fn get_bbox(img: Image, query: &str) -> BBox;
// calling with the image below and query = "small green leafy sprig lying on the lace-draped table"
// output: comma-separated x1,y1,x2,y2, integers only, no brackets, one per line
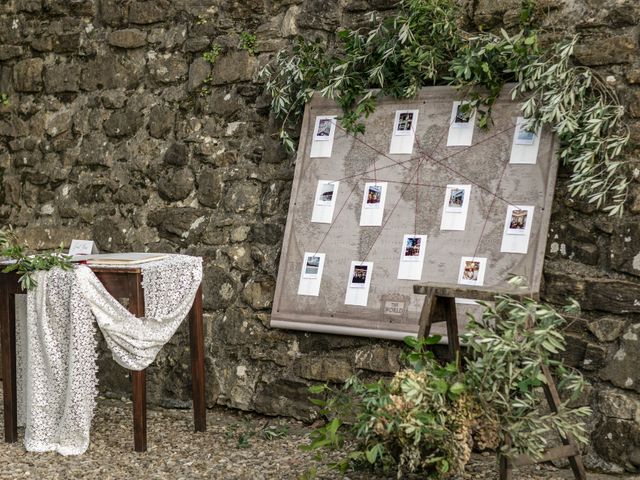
0,228,73,290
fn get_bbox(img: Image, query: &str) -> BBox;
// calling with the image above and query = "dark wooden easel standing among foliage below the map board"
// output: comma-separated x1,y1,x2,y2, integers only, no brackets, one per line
413,284,587,480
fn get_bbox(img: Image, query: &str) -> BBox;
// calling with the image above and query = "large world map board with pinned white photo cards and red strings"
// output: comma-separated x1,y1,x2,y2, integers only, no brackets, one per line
271,86,557,339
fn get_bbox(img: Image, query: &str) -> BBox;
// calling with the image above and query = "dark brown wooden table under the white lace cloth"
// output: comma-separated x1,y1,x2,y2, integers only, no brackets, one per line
0,266,207,452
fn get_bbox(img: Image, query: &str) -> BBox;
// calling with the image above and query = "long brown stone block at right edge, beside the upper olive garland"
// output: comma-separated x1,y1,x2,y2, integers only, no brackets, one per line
574,30,640,66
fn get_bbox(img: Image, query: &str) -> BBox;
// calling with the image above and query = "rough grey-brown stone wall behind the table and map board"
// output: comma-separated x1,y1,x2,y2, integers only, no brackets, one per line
0,0,640,471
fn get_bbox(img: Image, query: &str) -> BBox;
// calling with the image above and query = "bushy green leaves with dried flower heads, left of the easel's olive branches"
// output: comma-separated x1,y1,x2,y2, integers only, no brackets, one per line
307,350,472,478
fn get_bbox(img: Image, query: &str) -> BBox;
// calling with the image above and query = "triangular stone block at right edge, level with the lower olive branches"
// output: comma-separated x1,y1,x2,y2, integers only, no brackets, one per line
600,324,640,392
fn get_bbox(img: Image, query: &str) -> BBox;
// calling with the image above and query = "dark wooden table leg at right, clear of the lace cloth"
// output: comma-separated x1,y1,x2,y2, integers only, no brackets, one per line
189,287,207,432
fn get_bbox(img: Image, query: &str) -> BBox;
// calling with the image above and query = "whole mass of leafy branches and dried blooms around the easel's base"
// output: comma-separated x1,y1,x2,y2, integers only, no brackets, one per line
305,294,591,478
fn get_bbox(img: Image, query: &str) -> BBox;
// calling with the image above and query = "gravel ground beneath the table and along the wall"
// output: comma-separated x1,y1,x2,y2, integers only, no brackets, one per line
0,399,638,480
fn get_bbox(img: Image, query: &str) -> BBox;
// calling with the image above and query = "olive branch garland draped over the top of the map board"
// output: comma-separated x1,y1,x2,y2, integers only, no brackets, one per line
260,0,629,215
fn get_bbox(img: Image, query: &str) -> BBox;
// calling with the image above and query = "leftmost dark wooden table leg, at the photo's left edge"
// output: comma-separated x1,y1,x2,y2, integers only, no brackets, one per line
0,286,18,443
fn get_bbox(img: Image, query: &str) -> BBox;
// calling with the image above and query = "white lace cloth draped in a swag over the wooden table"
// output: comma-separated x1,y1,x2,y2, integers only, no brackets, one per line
16,255,202,455
